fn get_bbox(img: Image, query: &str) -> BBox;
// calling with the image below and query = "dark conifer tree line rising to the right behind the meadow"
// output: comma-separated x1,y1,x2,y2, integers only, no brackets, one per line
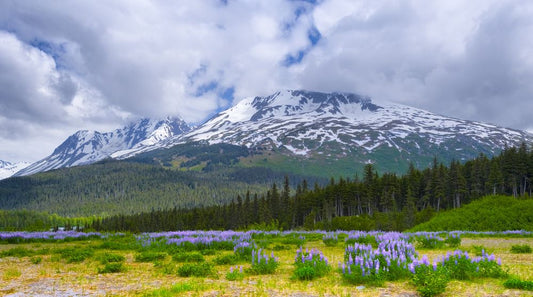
91,144,533,232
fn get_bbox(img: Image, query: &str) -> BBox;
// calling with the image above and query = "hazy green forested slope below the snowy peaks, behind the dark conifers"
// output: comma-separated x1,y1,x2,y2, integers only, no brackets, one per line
0,144,325,216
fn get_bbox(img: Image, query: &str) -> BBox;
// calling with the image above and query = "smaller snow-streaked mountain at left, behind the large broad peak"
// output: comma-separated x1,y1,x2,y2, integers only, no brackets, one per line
15,118,191,176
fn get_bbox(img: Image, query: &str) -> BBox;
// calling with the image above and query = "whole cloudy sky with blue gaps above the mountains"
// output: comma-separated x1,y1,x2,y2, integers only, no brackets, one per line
0,0,533,161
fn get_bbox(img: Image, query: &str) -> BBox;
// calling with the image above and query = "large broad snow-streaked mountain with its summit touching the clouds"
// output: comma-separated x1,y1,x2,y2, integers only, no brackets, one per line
171,90,533,162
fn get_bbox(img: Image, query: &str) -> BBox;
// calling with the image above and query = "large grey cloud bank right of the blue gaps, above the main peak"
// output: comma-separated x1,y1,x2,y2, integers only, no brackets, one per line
300,1,533,129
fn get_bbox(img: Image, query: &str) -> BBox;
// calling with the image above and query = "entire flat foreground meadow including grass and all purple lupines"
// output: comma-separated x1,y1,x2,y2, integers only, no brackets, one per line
0,231,533,296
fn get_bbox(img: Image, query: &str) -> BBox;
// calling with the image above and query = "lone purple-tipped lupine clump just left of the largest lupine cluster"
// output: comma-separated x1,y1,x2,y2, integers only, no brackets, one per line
294,247,331,280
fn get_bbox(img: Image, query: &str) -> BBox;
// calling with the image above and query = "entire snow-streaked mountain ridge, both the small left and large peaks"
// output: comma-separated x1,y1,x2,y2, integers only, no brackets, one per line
8,90,533,175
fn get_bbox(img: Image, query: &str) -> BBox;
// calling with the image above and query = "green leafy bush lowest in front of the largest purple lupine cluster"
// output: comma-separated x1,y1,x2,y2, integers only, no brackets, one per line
411,264,449,297
